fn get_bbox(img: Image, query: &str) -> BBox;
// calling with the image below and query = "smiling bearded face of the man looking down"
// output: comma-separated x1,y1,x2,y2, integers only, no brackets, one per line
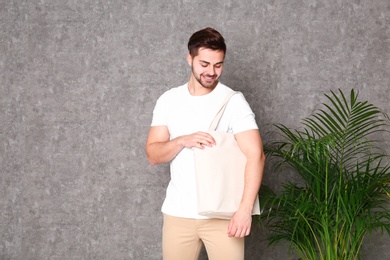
188,48,225,88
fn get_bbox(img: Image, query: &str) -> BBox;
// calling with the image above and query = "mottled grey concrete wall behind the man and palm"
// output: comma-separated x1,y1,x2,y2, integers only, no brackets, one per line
0,0,390,260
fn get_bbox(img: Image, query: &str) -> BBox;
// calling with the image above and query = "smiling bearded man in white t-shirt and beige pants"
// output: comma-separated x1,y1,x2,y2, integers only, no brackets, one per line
146,28,264,260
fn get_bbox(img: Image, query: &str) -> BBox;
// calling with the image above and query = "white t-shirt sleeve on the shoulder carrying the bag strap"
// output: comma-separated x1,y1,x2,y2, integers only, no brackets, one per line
226,93,258,134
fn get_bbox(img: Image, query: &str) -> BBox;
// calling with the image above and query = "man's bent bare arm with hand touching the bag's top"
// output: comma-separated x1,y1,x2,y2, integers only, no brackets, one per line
146,126,215,165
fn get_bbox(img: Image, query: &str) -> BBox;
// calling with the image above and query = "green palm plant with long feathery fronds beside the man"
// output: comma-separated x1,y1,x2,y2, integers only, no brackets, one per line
259,90,390,260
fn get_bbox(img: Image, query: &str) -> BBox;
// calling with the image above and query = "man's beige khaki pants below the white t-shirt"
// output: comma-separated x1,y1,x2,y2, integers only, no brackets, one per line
163,214,244,260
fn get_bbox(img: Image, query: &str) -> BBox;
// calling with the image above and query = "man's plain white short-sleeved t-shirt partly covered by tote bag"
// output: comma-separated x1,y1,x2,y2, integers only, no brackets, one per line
151,83,258,219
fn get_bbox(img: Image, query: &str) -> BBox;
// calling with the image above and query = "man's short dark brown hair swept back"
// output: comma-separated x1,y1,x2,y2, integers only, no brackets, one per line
188,27,226,57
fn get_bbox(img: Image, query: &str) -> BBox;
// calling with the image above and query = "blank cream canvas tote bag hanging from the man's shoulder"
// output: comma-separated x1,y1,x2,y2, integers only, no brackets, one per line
194,91,260,219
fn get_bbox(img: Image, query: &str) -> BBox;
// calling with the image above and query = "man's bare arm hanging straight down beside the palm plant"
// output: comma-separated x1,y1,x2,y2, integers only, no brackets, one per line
228,129,265,237
